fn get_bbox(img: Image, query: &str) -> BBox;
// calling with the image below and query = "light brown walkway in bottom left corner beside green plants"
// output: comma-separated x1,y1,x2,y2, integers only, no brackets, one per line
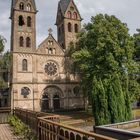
0,124,21,140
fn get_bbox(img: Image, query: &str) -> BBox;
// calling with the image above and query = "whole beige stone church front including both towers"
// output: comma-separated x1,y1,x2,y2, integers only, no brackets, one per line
10,0,84,111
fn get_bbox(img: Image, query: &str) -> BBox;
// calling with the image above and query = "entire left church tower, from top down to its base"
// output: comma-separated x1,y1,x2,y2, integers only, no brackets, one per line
10,0,37,108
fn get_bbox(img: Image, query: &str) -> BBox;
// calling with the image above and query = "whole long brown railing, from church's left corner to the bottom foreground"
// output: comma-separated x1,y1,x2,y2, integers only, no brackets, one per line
15,108,115,140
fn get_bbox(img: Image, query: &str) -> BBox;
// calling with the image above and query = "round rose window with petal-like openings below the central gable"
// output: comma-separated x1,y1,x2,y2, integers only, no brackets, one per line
45,62,57,76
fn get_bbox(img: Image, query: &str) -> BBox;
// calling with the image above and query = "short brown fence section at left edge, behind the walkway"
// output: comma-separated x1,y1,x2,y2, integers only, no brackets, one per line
0,108,11,124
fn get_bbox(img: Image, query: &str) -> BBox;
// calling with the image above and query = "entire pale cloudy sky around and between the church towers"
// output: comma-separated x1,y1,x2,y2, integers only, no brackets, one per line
0,0,140,50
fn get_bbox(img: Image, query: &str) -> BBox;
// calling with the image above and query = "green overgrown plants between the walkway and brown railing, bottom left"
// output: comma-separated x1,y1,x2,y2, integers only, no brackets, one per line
9,116,37,140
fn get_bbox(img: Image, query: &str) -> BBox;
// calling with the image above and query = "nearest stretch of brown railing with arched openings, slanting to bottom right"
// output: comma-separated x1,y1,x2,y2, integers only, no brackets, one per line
38,118,115,140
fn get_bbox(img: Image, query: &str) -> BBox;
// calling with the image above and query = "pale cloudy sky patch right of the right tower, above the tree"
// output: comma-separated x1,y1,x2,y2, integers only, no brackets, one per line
75,0,140,34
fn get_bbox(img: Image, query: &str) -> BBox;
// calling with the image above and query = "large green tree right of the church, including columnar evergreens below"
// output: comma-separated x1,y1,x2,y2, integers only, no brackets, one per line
72,14,136,125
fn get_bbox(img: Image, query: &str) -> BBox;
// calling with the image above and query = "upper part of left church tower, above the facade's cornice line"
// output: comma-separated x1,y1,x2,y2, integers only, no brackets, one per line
10,0,37,52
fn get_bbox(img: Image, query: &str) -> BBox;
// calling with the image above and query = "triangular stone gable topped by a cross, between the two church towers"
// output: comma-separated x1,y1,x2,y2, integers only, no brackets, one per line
37,34,64,55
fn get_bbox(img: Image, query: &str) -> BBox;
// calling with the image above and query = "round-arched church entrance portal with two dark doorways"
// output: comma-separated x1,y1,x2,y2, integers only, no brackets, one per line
41,86,62,112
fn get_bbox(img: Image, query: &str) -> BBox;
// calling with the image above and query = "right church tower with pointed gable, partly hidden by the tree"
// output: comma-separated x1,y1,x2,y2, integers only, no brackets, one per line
56,0,82,49
